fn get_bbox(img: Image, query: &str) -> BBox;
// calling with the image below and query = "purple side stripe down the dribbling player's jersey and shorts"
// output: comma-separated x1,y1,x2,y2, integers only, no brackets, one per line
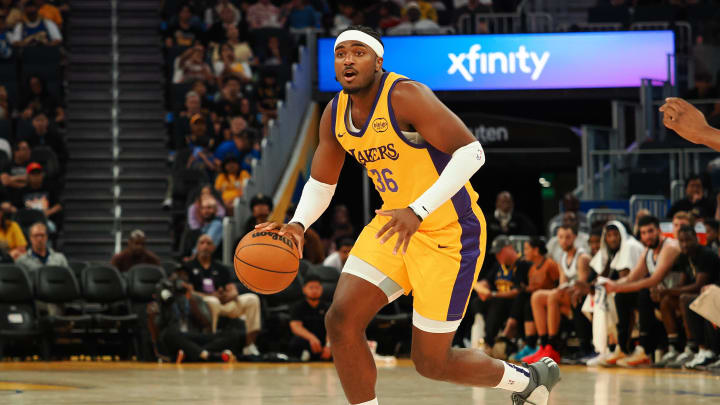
427,145,481,321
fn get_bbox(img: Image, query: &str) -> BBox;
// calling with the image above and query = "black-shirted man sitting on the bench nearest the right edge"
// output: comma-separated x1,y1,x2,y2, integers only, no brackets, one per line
655,225,720,366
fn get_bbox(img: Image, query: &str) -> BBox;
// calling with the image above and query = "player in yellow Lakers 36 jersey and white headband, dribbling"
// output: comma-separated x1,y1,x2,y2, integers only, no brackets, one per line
258,26,560,405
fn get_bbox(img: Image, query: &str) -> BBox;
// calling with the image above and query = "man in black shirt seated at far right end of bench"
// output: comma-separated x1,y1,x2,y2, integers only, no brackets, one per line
656,225,720,366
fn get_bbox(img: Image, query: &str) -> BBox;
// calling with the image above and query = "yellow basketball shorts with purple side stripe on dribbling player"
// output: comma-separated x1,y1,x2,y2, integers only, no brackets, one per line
343,206,487,332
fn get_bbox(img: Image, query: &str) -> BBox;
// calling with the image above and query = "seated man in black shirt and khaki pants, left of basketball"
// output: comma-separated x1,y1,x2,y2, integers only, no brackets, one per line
178,234,260,355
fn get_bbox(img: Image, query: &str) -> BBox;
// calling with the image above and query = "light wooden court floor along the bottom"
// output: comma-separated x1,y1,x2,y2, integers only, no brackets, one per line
0,360,720,405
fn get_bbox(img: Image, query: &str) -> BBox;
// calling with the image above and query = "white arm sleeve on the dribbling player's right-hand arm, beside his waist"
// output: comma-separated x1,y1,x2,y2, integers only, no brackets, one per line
410,141,485,219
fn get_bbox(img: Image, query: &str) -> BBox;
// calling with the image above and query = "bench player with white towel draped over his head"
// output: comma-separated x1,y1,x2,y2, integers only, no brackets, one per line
577,221,645,366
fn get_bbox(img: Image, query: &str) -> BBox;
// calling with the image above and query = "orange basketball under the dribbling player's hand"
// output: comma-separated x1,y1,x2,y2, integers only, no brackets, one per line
234,230,300,294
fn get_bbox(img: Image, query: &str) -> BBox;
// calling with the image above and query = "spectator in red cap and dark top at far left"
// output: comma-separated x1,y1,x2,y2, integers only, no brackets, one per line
15,162,62,233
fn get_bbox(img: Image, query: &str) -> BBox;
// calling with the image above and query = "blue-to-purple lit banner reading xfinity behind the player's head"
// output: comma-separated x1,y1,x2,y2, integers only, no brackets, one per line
318,31,675,92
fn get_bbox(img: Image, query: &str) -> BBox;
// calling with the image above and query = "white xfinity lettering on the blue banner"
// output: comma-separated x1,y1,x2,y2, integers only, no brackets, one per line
448,44,550,82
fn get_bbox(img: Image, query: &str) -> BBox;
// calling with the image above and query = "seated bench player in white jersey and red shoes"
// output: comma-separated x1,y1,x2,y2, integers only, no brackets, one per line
523,225,590,361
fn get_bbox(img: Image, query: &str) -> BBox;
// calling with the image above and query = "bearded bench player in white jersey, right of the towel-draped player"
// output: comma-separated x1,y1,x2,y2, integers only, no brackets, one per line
605,215,680,367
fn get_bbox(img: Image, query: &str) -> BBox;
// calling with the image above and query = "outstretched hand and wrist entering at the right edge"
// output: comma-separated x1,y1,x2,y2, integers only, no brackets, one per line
660,97,720,151
